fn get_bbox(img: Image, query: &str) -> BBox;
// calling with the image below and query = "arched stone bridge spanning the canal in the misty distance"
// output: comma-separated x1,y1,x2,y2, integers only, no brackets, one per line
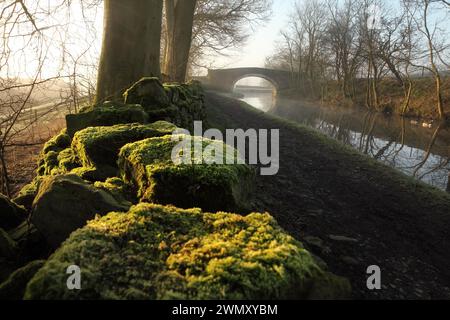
198,68,298,92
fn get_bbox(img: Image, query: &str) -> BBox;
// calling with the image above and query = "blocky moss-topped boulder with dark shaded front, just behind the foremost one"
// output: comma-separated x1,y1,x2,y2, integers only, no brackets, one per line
118,135,254,211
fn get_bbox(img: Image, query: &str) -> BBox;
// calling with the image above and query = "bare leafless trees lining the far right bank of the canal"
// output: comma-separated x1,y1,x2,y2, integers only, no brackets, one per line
267,0,450,118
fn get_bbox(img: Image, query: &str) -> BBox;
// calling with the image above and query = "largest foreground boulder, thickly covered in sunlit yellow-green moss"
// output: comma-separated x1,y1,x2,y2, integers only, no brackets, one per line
25,204,350,300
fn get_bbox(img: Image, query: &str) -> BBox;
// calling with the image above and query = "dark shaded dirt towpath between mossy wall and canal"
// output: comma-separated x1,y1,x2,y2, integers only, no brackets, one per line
206,93,450,299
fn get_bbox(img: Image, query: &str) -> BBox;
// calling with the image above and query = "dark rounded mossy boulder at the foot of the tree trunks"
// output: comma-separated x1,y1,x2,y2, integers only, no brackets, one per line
123,78,170,112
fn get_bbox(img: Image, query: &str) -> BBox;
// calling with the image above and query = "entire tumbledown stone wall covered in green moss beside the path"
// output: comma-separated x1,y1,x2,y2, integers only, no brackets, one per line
0,78,350,299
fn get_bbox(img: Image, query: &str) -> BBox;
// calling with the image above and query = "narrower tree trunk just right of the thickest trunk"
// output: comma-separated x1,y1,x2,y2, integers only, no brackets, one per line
163,0,197,83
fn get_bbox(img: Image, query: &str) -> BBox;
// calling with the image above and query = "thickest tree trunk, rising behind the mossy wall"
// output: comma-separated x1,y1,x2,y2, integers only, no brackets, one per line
96,0,163,103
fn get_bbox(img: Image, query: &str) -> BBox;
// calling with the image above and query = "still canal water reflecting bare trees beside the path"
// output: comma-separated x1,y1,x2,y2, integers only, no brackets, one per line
239,90,450,190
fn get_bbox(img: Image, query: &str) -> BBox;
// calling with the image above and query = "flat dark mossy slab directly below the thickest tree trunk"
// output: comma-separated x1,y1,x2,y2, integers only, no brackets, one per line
66,102,148,137
